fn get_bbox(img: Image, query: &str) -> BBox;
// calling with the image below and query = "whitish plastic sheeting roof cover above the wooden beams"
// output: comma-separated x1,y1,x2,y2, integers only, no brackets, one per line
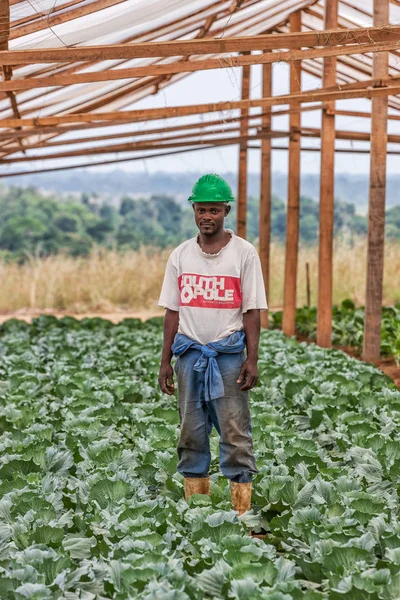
0,0,400,173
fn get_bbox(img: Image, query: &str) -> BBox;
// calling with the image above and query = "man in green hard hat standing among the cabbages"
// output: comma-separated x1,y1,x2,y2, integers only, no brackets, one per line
159,175,267,514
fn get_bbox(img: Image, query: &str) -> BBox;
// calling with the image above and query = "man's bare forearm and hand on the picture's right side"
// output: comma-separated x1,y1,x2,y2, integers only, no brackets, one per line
237,308,261,390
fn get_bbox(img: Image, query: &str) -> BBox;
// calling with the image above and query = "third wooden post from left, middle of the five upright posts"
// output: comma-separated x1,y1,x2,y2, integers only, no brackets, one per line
282,11,301,336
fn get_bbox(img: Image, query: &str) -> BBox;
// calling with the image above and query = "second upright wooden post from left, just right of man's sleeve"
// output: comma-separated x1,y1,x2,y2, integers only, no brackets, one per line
259,56,272,328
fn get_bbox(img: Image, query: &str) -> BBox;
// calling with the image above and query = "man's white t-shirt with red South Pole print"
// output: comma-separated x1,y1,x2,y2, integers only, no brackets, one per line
158,229,267,344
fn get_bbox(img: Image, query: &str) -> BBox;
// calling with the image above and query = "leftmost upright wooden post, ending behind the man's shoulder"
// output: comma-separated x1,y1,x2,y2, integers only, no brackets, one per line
236,53,251,239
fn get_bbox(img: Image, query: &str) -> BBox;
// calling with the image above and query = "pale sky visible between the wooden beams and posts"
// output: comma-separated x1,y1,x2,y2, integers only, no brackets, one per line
83,63,400,174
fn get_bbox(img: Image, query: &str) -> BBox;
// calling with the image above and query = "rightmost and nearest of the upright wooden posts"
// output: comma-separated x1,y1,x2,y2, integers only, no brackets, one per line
363,0,389,362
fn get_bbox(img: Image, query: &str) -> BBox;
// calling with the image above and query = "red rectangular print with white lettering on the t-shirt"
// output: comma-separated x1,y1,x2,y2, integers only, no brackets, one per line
178,273,242,308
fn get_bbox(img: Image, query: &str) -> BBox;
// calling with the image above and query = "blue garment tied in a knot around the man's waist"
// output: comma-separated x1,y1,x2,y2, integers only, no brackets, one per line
171,330,245,402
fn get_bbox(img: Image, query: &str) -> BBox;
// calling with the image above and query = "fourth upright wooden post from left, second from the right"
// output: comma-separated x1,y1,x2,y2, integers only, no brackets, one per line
317,0,338,348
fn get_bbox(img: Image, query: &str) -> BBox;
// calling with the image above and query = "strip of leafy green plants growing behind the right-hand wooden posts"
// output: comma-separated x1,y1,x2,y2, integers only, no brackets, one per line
270,299,400,366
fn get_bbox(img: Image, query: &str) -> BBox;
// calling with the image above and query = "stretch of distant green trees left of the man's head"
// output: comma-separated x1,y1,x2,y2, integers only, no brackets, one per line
0,188,188,261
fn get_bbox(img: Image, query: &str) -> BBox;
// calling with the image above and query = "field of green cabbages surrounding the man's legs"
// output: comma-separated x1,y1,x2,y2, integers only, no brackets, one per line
0,317,400,600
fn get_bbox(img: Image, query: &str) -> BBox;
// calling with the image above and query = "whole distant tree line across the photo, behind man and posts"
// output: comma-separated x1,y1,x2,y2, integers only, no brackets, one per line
0,187,400,261
